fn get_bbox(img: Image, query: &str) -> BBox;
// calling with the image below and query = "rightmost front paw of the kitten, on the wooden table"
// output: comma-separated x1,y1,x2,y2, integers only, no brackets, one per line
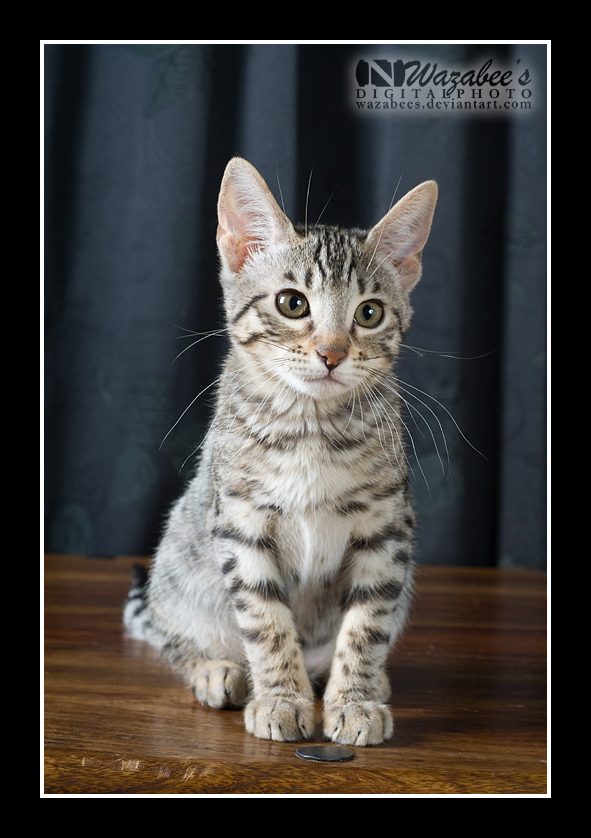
324,701,394,746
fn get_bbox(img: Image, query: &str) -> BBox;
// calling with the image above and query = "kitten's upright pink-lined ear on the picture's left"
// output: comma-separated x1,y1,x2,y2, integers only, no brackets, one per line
217,157,293,273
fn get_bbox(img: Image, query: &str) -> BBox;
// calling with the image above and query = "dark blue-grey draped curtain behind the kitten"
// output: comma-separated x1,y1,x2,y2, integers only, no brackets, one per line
44,43,546,568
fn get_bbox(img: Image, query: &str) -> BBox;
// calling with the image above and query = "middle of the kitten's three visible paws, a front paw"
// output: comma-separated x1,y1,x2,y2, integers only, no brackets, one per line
244,698,314,742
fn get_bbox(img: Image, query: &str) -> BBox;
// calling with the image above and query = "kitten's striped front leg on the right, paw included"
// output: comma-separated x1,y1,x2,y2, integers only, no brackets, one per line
324,545,412,746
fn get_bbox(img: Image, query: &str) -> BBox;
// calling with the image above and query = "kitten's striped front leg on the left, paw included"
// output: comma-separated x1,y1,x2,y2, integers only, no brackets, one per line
223,530,314,742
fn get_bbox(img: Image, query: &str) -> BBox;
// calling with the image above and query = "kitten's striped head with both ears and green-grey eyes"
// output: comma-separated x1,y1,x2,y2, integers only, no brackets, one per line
217,158,437,400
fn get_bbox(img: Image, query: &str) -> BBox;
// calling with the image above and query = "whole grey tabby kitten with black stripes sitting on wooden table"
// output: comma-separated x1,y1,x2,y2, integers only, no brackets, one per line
125,158,437,745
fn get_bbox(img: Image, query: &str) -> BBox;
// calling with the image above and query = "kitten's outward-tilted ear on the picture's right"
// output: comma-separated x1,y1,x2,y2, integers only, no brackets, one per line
367,180,438,291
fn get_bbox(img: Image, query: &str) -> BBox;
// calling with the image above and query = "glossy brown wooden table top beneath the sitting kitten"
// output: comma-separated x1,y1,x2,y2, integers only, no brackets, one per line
42,555,549,796
